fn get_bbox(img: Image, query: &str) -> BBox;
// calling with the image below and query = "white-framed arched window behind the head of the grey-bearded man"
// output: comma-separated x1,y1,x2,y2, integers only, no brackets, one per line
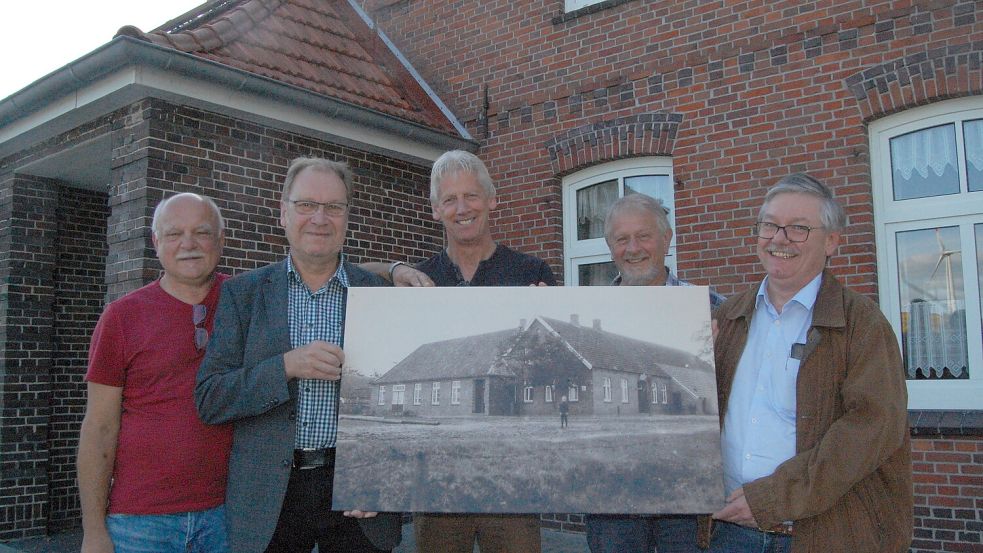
563,157,676,286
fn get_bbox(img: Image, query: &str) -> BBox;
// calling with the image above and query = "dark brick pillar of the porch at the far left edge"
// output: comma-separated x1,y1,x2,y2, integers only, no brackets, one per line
0,176,57,540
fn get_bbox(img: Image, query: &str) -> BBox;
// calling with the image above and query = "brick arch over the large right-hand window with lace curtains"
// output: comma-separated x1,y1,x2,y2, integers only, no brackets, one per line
846,43,983,121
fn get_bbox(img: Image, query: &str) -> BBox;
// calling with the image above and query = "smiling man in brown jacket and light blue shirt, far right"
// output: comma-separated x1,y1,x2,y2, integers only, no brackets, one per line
710,174,912,553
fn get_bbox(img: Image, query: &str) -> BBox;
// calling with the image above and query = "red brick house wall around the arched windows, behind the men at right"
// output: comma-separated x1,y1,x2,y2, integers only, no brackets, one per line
367,0,983,551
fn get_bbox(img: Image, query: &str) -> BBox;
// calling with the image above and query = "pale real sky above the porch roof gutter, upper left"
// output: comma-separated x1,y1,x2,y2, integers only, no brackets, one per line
0,0,203,99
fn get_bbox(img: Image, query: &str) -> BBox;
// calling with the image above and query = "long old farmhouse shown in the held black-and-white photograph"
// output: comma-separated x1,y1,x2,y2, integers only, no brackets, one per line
371,315,717,417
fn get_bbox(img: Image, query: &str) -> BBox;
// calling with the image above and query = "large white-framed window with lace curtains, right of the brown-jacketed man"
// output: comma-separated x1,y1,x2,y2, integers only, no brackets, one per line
870,97,983,409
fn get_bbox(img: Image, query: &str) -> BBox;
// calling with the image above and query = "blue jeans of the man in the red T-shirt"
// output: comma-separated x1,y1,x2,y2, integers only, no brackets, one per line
106,505,229,553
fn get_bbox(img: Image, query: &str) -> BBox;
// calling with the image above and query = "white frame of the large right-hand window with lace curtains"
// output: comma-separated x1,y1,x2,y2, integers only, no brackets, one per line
869,96,983,410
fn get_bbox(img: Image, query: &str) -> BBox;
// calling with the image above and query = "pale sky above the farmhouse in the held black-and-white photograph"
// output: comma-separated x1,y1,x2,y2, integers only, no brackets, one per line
345,286,710,376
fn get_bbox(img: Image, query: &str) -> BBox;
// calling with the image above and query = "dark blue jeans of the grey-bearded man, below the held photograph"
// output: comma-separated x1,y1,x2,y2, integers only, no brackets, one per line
584,515,702,553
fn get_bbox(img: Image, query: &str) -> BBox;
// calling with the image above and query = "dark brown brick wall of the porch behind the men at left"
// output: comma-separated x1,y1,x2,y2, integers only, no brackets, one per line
0,99,449,541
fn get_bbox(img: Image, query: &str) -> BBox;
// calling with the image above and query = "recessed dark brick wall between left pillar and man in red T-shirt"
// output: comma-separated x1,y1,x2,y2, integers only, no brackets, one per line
48,185,109,530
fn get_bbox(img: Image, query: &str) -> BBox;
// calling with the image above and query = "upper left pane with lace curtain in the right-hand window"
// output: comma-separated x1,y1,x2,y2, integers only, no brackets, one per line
891,124,959,200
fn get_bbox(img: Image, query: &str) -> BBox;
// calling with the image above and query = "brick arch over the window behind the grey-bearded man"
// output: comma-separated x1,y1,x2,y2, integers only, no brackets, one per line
546,112,683,177
